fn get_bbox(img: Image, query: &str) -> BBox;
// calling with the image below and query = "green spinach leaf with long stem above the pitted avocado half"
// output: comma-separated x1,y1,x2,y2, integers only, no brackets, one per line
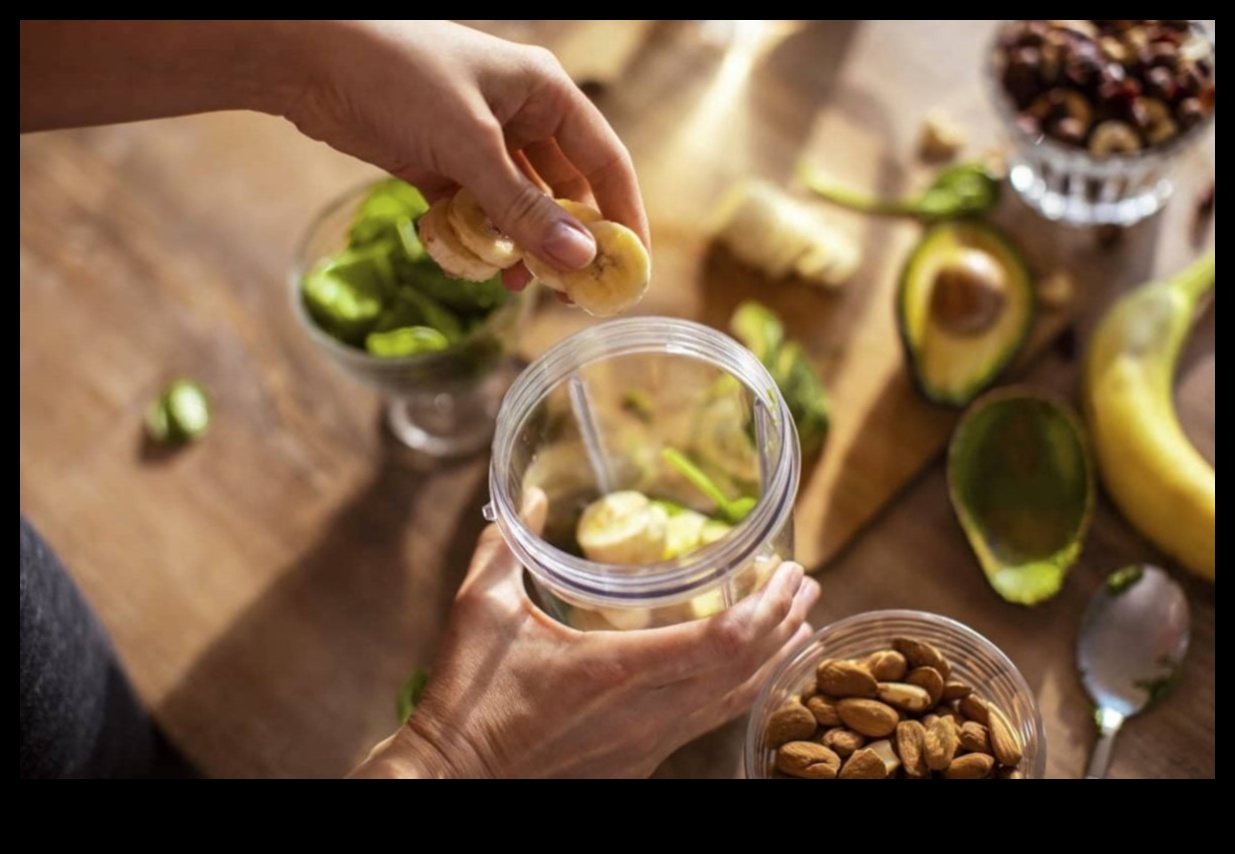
799,162,1000,220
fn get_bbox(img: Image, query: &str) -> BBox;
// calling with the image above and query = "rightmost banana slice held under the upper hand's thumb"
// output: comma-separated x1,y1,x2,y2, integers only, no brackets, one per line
536,220,652,318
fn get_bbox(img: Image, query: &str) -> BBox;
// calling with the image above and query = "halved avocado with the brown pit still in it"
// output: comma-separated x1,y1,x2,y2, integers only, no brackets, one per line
897,220,1035,407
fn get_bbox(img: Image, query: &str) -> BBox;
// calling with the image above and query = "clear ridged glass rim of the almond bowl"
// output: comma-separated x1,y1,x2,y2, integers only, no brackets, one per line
743,608,1046,779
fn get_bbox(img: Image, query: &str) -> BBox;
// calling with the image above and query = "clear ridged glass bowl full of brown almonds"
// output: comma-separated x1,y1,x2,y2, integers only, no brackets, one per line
746,611,1046,780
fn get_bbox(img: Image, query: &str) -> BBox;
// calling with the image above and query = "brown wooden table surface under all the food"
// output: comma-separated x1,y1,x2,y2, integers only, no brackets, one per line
20,21,1215,777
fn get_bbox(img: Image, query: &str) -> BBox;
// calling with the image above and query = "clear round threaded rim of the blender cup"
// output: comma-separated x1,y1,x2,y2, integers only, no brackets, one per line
489,316,800,607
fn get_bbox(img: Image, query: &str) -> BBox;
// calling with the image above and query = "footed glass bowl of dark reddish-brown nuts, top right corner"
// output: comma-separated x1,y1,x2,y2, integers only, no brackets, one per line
987,20,1216,226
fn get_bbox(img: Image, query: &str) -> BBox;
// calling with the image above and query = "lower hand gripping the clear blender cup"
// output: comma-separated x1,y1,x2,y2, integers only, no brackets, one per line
353,486,819,777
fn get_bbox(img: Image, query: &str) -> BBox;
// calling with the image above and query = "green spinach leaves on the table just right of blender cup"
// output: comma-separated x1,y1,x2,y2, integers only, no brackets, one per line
729,300,831,457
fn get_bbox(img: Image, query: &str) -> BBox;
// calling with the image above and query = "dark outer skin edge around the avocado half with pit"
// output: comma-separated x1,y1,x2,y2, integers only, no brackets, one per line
897,219,1037,408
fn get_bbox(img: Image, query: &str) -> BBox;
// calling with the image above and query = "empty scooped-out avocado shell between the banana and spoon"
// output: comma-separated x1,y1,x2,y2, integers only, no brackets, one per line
947,388,1094,606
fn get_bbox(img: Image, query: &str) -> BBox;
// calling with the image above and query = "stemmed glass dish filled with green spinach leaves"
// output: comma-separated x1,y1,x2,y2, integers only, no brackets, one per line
289,178,530,457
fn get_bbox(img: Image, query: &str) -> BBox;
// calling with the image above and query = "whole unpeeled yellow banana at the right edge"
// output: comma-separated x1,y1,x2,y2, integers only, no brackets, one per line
1083,252,1216,581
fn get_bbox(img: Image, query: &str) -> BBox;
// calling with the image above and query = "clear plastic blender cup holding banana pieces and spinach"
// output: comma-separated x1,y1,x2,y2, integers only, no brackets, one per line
485,318,800,630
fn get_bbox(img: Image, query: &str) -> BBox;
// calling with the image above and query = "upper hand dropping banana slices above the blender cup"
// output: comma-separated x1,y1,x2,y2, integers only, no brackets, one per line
287,21,650,289
